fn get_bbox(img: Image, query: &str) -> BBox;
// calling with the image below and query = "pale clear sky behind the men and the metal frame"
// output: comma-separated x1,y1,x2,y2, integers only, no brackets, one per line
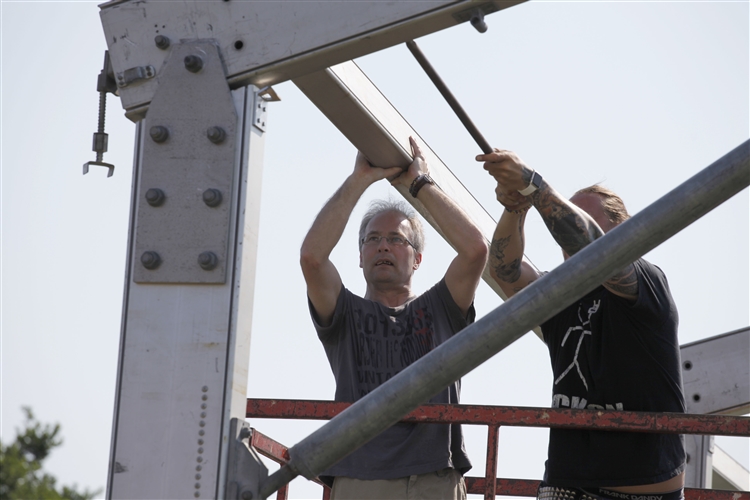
0,0,750,498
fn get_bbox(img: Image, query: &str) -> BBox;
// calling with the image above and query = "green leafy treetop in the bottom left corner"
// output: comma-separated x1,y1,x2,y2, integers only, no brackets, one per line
0,407,101,500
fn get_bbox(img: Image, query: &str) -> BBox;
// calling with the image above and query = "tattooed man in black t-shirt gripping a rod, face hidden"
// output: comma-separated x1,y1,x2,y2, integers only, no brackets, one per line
477,149,685,500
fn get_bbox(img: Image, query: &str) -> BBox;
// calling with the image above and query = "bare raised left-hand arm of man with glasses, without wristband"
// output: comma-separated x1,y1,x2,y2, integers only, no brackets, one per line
300,153,401,326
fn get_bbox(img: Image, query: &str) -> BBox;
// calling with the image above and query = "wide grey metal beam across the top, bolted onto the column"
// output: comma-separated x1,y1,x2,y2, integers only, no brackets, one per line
101,0,525,120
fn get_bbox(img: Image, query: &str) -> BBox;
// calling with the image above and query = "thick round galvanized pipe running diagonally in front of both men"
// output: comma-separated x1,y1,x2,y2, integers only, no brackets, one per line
261,140,750,498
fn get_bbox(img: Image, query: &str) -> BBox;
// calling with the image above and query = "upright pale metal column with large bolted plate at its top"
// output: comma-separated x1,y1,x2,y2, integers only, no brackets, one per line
107,41,265,499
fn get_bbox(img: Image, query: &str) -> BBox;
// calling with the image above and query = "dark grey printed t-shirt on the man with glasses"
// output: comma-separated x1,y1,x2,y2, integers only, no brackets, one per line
308,280,475,480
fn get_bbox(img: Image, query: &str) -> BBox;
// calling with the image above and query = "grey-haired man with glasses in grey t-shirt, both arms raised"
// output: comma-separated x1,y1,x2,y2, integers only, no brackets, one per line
300,138,488,500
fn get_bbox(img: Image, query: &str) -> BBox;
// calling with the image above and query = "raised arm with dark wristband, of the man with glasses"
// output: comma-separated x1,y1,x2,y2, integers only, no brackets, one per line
392,137,487,314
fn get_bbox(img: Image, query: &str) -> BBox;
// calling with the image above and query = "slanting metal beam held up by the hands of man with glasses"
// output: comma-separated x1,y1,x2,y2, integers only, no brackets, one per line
292,57,542,339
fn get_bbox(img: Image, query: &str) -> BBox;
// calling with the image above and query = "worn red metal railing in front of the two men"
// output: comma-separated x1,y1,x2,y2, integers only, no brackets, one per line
246,399,750,500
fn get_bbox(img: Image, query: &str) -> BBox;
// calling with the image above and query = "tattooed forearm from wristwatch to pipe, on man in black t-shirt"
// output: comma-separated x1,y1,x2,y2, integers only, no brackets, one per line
532,184,604,255
